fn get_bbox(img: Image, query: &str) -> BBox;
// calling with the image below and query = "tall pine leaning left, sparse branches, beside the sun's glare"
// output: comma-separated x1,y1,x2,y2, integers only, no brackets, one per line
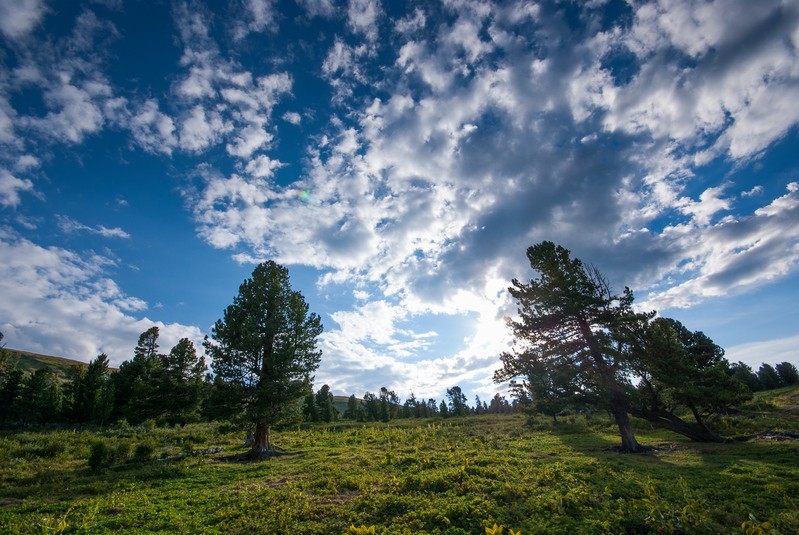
494,241,646,452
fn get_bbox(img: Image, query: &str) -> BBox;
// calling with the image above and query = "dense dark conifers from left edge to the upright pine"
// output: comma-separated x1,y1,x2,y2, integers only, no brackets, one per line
0,327,206,427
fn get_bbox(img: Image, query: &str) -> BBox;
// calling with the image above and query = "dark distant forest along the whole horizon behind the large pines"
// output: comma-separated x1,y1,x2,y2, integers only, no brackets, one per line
0,327,799,427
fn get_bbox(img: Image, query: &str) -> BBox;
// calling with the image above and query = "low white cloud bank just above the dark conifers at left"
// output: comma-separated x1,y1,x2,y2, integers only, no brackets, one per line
0,232,202,366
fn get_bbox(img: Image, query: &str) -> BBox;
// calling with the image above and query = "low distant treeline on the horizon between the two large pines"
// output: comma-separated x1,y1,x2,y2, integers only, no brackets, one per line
302,385,524,422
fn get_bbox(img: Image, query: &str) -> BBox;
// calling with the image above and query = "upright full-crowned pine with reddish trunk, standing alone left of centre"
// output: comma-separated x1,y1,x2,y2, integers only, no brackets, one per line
204,261,322,458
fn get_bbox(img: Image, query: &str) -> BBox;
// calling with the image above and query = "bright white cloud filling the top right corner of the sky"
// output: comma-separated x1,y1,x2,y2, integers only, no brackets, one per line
603,0,799,160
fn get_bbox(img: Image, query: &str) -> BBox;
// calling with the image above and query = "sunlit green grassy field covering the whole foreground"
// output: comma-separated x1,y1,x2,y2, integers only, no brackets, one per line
0,389,799,535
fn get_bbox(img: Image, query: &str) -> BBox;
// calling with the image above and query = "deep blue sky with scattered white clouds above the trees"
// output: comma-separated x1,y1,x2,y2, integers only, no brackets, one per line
0,0,799,399
